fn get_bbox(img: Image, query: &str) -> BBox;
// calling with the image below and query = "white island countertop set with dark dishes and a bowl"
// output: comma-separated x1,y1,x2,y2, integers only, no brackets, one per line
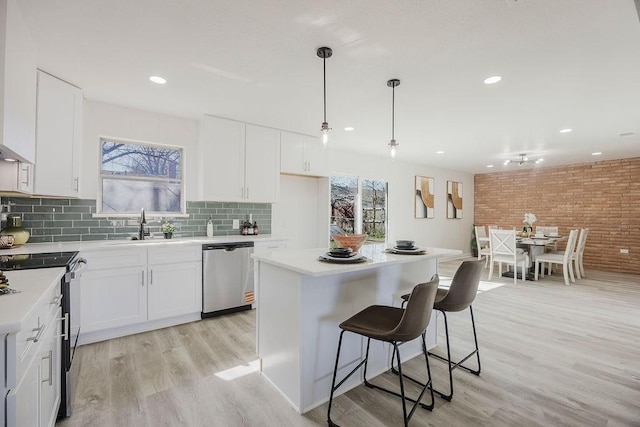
252,243,462,276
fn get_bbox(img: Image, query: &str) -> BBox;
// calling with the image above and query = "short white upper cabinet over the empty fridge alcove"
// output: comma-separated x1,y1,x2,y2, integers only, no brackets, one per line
280,131,327,176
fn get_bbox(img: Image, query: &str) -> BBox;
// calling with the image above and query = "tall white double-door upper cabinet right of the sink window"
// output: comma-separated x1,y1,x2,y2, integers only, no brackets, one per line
200,116,280,203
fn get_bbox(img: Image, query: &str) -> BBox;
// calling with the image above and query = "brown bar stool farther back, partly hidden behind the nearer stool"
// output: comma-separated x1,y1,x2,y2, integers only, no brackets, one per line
392,261,483,401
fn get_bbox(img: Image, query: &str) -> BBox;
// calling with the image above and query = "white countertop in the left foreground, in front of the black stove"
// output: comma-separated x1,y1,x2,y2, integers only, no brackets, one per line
0,267,66,336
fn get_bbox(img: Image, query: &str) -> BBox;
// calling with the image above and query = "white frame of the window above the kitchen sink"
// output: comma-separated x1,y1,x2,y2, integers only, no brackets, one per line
92,136,189,218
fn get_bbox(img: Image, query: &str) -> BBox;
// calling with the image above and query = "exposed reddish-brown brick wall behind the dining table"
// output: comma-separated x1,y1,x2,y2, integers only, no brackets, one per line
474,157,640,274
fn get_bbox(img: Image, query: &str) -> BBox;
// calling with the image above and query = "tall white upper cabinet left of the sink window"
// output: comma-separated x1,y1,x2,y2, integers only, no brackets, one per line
34,71,83,197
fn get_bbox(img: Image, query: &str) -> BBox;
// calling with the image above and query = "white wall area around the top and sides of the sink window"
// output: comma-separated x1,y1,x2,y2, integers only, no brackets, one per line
81,100,200,200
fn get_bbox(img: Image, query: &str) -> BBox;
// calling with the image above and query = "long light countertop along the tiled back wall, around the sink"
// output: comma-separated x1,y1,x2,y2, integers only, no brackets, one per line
0,234,288,256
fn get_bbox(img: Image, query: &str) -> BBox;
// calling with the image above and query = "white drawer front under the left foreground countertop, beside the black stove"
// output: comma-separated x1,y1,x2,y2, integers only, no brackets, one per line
6,286,62,389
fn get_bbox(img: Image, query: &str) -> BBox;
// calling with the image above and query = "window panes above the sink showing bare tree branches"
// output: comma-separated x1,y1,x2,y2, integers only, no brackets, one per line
99,140,183,214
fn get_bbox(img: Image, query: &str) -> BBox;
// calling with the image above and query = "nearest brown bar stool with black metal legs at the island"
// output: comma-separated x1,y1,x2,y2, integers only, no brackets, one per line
327,274,439,426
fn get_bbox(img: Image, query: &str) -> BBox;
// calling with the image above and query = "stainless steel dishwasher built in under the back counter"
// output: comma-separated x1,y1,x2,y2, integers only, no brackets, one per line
202,242,253,318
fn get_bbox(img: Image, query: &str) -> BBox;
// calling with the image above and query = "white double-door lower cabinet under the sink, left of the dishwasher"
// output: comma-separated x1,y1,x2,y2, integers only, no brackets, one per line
80,245,202,344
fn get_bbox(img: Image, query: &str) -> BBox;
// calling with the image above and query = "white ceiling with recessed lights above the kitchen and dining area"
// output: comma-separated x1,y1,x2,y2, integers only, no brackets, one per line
18,0,640,173
